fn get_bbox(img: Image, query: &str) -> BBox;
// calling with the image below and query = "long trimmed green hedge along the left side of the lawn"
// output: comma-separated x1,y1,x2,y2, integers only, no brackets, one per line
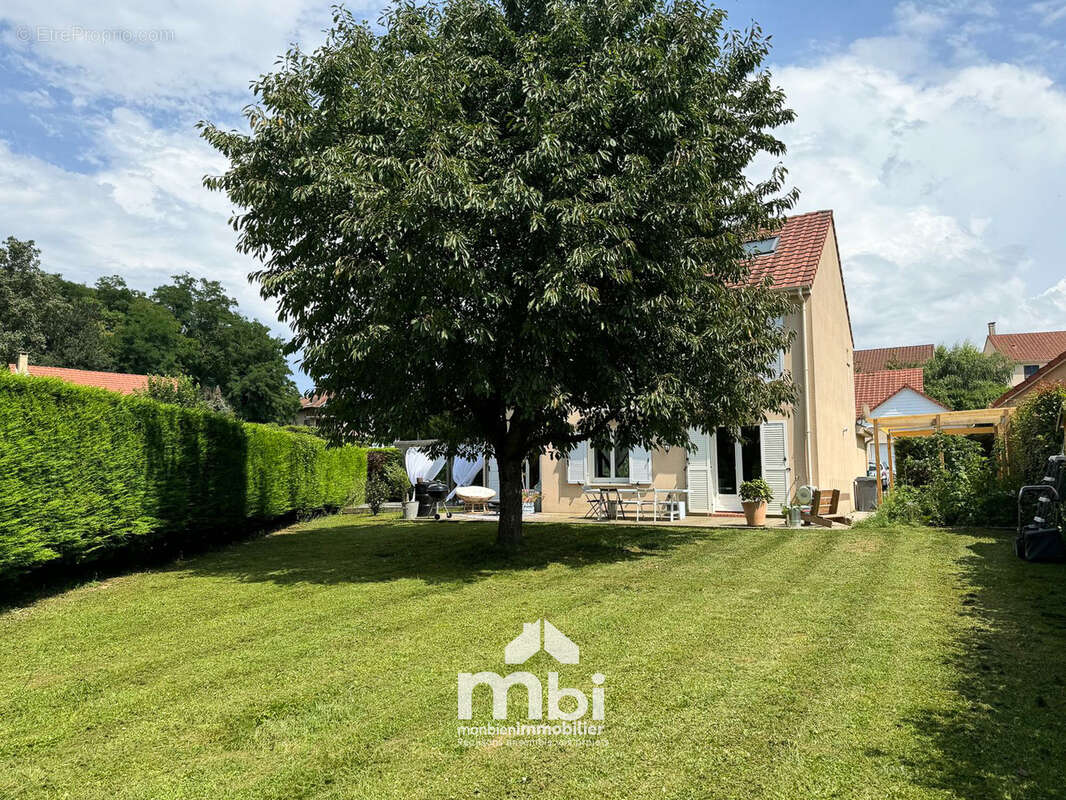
0,373,367,580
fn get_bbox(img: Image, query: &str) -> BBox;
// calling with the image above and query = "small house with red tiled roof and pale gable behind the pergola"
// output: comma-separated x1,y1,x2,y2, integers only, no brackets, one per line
855,367,951,469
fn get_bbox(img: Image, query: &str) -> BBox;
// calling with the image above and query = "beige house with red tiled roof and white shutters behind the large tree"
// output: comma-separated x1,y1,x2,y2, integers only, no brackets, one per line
540,211,866,513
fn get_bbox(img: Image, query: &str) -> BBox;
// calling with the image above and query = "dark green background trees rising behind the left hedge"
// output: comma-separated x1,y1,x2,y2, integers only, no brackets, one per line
0,237,300,422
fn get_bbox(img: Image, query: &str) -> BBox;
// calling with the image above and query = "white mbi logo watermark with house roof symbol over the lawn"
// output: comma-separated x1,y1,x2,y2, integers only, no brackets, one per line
457,620,605,745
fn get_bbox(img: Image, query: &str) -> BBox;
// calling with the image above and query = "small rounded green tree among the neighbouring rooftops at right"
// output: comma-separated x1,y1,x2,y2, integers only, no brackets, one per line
922,342,1014,411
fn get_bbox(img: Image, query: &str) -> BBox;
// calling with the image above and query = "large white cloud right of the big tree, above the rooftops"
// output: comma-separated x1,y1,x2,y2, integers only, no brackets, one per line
774,14,1066,347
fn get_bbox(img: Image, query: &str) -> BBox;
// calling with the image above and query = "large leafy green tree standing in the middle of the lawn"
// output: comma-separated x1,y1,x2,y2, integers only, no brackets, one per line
203,0,794,547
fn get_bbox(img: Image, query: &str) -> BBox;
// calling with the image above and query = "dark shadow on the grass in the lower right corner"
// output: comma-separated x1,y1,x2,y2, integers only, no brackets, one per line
912,532,1066,799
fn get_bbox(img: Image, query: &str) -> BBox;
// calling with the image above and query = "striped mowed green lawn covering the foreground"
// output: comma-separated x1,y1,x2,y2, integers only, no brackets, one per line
0,516,1066,800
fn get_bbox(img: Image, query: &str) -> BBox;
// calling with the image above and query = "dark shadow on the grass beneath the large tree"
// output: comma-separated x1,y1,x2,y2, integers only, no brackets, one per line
174,522,721,585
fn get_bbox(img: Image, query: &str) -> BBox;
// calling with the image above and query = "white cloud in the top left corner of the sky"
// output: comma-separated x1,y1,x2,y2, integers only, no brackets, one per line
0,0,329,112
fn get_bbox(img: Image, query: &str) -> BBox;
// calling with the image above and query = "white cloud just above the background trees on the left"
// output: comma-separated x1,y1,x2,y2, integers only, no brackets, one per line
0,109,286,345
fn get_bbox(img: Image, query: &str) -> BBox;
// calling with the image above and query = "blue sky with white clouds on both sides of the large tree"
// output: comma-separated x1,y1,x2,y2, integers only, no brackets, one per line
0,0,1066,389
